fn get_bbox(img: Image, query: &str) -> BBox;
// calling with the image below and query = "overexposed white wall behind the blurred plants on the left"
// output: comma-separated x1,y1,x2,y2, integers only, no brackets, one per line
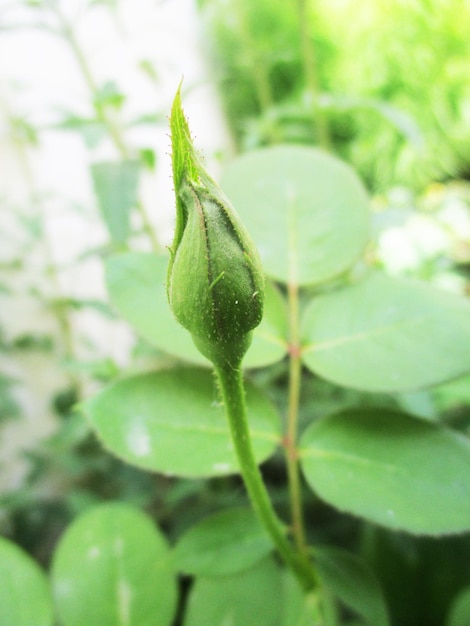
0,0,230,490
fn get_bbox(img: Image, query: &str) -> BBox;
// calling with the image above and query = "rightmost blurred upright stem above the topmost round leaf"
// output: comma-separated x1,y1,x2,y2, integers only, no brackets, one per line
297,0,331,150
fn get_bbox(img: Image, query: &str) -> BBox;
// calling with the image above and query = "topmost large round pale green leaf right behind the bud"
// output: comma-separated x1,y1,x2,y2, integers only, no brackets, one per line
222,146,369,285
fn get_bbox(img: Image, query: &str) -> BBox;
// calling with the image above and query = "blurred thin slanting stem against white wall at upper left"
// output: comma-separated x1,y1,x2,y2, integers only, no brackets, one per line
53,4,160,251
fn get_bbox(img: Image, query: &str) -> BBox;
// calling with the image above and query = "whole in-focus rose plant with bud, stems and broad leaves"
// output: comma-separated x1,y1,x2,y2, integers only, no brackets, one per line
0,91,470,626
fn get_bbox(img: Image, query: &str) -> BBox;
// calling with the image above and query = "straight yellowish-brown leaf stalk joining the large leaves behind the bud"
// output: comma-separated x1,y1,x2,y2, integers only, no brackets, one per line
285,281,307,554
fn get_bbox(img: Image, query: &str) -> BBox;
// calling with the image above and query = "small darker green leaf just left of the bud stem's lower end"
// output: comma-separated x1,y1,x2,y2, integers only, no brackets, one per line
174,508,272,577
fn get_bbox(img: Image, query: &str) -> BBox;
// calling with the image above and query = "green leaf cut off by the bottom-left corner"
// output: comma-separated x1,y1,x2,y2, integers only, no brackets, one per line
0,537,54,626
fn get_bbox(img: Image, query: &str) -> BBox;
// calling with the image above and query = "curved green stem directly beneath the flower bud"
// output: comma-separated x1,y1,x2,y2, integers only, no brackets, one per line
215,364,318,591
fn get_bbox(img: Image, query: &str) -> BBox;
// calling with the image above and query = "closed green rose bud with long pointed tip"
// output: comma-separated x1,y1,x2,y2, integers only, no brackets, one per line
167,90,264,367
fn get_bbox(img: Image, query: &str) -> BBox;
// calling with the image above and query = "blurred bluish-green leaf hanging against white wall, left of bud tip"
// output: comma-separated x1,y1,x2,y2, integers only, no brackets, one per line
91,161,139,243
